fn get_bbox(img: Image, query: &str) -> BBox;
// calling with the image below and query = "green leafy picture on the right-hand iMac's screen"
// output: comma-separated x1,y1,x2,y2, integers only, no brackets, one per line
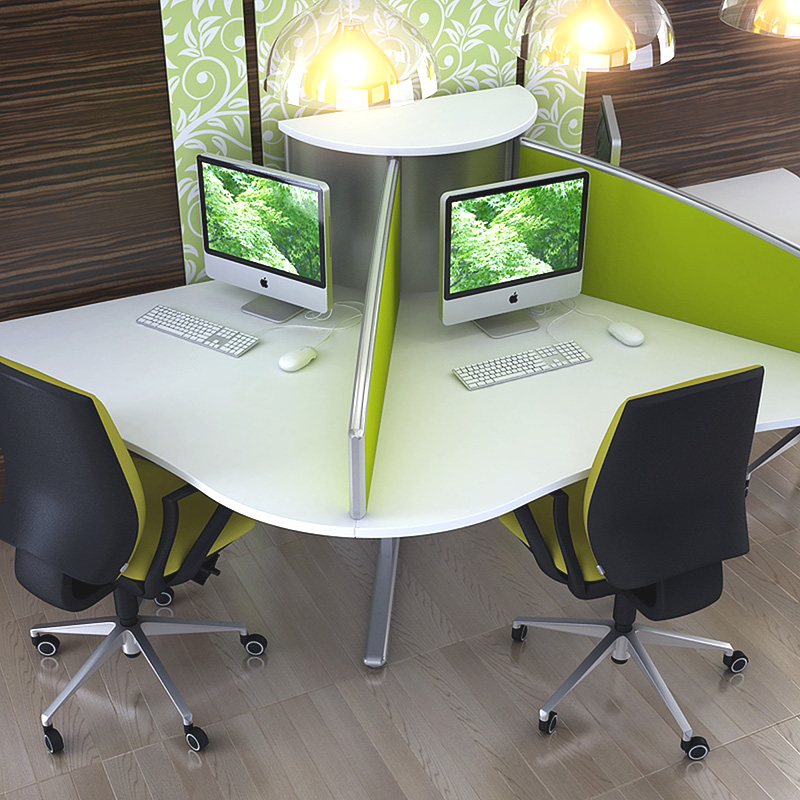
450,180,583,294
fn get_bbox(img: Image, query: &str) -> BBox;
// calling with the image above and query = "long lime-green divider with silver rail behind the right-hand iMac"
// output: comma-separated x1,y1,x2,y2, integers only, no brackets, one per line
520,139,800,352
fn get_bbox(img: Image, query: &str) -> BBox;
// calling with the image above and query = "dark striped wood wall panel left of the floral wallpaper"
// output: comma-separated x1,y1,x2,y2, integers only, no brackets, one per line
0,0,184,319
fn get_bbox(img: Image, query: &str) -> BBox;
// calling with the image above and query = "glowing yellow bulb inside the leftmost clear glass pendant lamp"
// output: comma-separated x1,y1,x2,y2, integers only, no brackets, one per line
303,20,398,109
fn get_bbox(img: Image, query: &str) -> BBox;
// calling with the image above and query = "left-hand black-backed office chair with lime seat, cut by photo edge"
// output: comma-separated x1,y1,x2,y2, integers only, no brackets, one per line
0,357,267,753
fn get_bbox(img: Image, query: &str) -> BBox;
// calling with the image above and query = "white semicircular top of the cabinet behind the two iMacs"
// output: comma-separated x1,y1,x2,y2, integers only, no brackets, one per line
278,86,537,156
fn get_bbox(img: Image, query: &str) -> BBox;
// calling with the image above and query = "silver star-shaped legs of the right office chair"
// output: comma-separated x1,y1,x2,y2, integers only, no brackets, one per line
512,617,747,758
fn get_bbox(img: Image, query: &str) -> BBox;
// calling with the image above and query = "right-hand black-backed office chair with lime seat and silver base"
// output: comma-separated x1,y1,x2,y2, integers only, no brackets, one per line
501,367,764,761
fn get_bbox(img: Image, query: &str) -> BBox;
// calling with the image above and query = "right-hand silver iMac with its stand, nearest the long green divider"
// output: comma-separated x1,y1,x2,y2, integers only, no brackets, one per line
439,170,589,338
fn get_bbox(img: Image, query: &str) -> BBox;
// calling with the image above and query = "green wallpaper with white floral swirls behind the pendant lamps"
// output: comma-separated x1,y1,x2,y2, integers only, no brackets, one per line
161,0,584,283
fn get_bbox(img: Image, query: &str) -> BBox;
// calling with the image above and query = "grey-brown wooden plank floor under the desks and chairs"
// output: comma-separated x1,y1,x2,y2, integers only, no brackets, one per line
0,434,800,800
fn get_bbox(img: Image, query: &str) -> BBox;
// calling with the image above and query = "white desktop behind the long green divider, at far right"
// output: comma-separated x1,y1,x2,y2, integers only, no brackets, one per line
682,169,800,247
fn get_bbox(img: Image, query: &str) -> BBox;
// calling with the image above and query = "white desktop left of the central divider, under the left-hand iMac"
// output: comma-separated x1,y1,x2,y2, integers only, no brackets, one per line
0,281,360,536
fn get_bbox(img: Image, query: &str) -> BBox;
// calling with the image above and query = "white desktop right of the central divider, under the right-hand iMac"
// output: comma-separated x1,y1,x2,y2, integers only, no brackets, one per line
356,294,800,537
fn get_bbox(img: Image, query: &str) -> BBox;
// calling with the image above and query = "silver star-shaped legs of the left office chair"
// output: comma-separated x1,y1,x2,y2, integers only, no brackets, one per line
30,616,253,731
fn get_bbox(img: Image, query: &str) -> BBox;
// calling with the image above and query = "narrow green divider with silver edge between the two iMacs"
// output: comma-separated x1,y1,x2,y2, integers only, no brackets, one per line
349,158,400,519
